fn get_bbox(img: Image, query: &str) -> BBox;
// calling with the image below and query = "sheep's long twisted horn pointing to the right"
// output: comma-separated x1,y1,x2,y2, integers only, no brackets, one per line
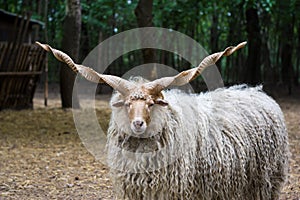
145,42,247,93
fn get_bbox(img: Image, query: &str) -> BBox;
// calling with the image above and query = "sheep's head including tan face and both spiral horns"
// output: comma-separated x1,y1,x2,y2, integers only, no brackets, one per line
36,42,246,134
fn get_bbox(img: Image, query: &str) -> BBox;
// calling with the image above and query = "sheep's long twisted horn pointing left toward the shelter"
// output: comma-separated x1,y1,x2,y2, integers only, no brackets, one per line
35,42,135,96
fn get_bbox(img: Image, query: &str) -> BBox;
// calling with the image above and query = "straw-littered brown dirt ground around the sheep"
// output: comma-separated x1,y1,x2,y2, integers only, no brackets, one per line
0,85,300,200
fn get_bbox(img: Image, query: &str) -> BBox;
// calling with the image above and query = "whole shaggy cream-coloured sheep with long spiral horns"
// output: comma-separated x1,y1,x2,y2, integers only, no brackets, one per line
38,43,289,200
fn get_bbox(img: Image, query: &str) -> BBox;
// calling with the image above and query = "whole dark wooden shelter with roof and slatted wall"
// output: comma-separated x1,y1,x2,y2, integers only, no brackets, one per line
0,10,46,110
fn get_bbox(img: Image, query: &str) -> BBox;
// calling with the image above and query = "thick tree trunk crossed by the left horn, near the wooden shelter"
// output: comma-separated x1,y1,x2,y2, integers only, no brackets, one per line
60,0,81,108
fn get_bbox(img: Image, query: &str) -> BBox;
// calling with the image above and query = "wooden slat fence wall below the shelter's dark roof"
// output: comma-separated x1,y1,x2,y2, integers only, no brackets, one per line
0,42,46,110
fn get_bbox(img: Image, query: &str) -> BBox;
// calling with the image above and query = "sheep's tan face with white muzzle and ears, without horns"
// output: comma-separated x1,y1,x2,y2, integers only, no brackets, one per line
113,85,168,135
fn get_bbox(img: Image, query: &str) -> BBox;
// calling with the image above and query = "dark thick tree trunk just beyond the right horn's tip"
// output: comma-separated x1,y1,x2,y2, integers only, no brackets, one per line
245,8,261,85
